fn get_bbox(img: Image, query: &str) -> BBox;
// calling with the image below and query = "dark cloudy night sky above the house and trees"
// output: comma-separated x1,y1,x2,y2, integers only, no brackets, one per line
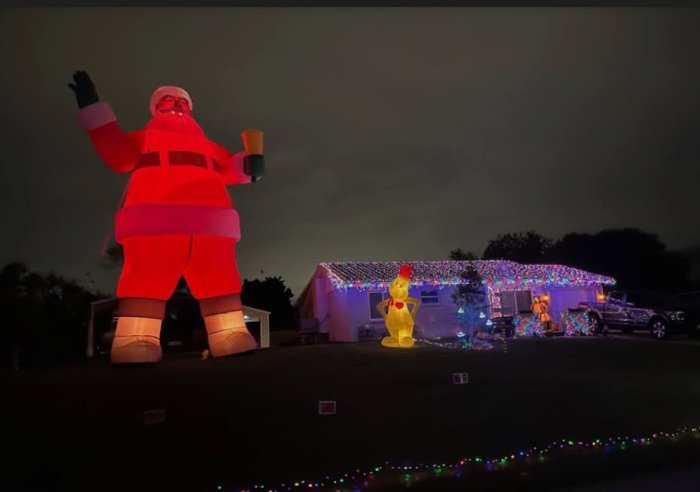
0,8,700,294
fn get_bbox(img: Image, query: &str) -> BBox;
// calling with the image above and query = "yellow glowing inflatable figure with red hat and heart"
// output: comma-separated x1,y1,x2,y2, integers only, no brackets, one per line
377,265,420,348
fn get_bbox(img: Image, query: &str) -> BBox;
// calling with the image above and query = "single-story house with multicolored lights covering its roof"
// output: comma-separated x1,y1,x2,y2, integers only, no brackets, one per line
296,260,615,342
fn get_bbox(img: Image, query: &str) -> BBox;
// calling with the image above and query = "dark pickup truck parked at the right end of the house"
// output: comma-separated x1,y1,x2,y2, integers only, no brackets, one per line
579,291,686,340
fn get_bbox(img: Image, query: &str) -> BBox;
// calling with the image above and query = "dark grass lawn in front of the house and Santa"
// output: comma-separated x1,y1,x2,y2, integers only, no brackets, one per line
0,337,700,490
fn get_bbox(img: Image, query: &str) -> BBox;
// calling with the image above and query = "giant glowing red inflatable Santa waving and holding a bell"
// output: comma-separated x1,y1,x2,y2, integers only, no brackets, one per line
68,72,264,364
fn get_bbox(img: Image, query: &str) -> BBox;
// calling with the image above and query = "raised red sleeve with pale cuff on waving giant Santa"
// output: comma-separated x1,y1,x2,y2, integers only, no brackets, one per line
77,101,143,173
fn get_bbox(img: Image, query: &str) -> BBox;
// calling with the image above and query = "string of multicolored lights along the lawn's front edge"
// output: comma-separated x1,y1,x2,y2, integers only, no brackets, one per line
226,427,700,492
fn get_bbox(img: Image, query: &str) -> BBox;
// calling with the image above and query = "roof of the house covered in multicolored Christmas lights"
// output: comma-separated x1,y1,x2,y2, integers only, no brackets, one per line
321,260,615,292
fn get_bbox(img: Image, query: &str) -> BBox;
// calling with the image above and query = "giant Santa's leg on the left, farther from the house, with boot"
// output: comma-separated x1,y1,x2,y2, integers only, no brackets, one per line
111,236,191,364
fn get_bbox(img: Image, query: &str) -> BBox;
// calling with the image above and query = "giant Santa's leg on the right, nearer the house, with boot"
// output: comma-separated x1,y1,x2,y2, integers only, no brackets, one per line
184,236,258,357
